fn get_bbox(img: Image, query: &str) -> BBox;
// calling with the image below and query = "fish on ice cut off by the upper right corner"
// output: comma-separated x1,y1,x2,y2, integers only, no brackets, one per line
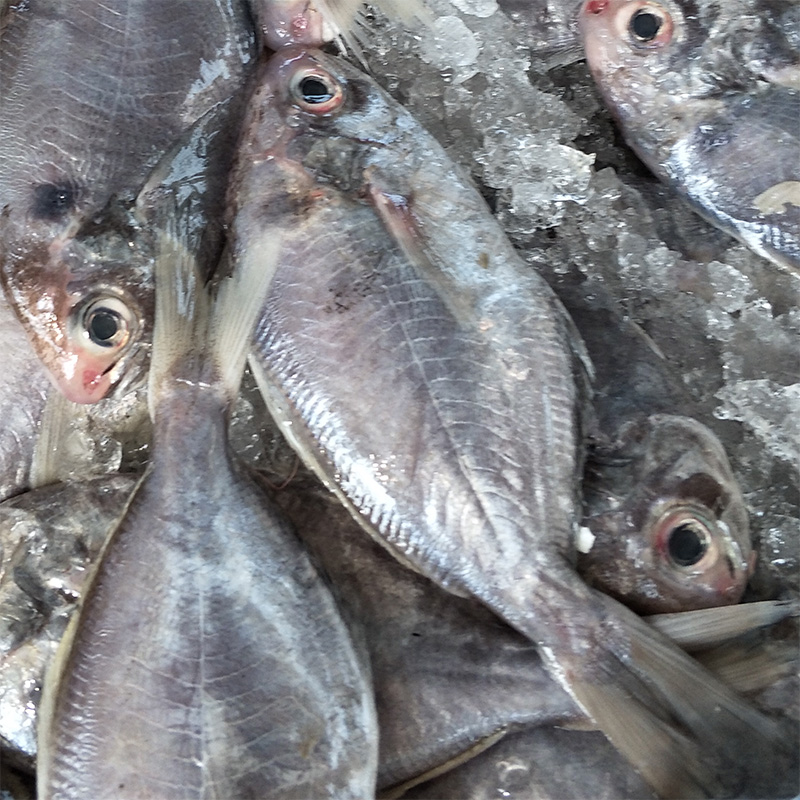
579,0,800,273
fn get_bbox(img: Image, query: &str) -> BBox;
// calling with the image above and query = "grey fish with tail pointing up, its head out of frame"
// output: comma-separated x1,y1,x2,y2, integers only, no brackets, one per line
37,228,377,800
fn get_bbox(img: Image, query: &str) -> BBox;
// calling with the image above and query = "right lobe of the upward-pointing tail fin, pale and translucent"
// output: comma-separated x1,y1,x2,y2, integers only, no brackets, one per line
211,228,281,399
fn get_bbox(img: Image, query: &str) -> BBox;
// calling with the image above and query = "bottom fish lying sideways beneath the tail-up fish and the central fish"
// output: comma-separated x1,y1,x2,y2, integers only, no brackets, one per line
0,460,794,794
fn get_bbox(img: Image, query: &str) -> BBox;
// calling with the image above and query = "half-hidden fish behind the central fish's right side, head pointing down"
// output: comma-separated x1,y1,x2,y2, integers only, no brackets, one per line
552,270,755,614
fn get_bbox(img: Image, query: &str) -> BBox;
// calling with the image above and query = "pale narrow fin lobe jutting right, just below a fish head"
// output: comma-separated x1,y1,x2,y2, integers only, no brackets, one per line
645,600,800,651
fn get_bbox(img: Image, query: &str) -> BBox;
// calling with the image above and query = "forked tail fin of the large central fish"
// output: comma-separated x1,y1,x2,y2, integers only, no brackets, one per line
543,593,798,798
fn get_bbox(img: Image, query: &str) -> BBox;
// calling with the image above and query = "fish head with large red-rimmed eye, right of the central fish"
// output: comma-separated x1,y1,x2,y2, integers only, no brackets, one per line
578,415,754,613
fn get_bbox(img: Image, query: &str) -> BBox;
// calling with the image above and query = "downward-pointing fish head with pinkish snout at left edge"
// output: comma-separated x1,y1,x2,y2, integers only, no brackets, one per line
0,182,153,403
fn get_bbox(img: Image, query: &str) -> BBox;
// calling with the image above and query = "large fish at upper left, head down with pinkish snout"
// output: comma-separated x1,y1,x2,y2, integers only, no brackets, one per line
0,0,254,403
